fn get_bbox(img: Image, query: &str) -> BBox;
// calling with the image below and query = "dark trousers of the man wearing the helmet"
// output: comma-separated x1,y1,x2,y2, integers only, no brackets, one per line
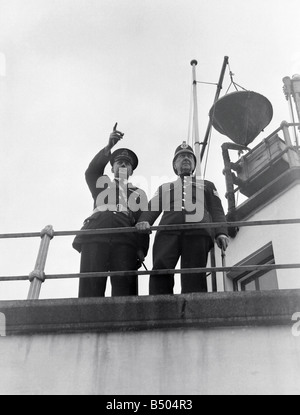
149,232,212,295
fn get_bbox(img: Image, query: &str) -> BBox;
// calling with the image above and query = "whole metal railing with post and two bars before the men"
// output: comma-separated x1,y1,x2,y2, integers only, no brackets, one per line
0,219,300,300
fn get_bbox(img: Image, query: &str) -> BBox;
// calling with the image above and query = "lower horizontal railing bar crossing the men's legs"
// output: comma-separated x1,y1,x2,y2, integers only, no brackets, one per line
0,264,300,282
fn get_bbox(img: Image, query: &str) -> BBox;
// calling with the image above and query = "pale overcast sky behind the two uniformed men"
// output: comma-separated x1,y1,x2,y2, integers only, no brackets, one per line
0,0,300,299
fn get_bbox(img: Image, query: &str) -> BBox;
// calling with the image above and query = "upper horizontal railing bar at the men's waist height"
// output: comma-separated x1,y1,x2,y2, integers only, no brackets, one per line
0,219,300,239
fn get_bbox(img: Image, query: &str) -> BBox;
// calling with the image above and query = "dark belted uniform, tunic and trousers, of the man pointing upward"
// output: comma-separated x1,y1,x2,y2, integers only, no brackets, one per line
73,149,149,297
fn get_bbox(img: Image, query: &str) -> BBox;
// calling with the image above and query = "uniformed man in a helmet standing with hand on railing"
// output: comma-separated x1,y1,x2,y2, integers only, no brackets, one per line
136,142,229,295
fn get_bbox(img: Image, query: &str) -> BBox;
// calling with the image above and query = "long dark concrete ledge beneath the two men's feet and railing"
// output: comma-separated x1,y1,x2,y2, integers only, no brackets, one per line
0,290,300,335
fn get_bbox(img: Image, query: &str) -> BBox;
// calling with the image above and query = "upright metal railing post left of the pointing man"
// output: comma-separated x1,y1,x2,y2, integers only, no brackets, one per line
27,225,54,300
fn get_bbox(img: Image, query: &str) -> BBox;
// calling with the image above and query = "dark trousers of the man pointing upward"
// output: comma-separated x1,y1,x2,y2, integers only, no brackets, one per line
79,242,138,298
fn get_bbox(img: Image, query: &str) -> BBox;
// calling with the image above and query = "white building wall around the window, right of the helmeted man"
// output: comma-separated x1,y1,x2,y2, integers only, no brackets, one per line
225,184,300,289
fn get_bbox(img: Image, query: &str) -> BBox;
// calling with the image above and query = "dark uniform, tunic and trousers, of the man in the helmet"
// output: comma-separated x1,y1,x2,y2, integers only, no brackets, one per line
139,177,227,295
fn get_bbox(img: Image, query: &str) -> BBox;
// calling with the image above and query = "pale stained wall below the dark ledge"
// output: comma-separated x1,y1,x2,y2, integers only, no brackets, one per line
0,324,300,395
